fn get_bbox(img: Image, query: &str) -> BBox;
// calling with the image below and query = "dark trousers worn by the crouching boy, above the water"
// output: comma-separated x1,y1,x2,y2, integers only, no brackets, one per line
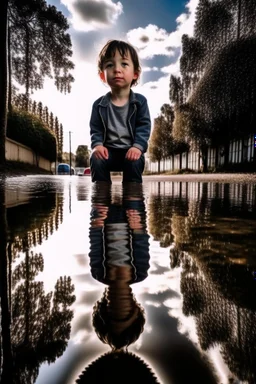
90,148,145,183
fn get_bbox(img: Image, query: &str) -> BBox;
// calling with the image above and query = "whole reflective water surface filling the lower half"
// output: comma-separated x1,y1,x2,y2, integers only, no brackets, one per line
0,176,256,384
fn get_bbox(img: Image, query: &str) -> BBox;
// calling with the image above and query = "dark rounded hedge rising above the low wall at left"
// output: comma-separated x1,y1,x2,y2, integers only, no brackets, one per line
6,110,57,162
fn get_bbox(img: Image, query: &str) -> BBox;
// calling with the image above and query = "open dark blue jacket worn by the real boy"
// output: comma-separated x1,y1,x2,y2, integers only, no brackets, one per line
90,90,151,153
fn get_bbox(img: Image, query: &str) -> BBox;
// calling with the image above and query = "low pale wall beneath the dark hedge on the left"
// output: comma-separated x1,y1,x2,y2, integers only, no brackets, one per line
5,138,52,171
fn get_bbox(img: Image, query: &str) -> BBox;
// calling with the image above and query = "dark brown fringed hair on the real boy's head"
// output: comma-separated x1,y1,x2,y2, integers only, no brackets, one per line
98,40,141,86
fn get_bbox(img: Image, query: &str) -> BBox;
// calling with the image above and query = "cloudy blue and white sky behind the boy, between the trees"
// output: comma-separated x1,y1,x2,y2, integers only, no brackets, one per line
33,0,198,153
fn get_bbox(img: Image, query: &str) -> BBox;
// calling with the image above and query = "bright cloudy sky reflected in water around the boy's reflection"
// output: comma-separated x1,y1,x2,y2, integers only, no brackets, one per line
25,179,233,384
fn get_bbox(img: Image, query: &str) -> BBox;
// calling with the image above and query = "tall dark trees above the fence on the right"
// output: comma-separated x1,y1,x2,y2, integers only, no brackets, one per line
149,0,256,169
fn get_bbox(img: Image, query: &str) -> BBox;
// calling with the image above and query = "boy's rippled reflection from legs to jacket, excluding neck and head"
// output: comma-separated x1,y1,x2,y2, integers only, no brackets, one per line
89,183,149,284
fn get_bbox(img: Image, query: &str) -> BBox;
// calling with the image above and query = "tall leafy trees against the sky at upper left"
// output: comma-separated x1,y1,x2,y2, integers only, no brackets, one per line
0,0,74,165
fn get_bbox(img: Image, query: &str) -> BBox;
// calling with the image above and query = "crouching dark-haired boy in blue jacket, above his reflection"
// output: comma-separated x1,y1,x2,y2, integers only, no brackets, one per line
90,40,151,183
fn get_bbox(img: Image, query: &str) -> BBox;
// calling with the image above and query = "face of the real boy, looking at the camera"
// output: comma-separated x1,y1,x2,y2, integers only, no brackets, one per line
100,50,138,89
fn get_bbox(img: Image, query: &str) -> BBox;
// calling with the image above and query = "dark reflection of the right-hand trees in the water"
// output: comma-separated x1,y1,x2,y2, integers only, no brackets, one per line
167,184,256,384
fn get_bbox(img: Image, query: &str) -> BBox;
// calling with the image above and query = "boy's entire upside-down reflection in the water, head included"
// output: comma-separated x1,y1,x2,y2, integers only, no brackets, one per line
89,185,149,350
